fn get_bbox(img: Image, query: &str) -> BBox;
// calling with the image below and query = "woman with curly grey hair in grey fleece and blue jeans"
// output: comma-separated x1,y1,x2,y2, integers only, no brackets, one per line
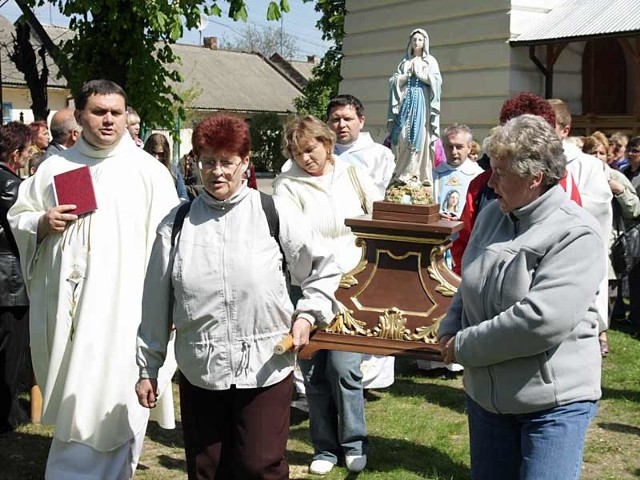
438,115,605,480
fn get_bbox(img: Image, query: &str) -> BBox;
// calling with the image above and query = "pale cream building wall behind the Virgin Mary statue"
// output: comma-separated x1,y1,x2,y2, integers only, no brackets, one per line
340,0,596,141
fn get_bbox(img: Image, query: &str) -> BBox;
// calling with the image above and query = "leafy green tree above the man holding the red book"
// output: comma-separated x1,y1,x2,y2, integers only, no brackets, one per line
19,0,289,128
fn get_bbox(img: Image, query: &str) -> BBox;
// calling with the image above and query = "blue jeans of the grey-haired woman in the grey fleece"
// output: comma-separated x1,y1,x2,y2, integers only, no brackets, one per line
466,396,598,480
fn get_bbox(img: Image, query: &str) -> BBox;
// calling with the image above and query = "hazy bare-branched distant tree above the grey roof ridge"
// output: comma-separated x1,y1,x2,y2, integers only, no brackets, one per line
222,25,300,58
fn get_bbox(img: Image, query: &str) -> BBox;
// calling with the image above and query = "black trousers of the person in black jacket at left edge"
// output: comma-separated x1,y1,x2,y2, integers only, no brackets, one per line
0,307,31,433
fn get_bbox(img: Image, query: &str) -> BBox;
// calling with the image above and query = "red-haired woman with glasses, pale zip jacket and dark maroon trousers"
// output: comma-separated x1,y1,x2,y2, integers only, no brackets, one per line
136,115,340,480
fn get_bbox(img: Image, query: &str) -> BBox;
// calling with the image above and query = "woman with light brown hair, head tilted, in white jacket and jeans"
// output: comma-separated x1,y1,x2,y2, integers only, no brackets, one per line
274,116,375,474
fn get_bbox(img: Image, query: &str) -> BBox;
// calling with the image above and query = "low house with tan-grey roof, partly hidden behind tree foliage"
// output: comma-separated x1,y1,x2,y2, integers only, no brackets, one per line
0,16,304,157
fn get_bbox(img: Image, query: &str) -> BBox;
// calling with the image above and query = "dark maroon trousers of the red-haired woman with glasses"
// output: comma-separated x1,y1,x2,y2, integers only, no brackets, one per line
180,373,293,480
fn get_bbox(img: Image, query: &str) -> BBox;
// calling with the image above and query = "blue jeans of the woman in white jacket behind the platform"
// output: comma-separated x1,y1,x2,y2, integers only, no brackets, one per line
298,350,368,464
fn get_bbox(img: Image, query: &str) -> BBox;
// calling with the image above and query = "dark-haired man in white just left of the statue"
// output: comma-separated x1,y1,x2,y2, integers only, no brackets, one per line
327,95,395,200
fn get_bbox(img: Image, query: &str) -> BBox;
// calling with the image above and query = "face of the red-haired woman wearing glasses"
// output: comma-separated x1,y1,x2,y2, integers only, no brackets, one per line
198,149,249,200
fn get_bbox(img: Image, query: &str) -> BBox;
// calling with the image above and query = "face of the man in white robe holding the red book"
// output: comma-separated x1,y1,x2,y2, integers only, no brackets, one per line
75,93,127,148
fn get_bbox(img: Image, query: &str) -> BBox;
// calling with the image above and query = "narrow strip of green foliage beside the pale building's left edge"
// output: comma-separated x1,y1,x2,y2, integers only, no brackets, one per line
294,0,347,119
